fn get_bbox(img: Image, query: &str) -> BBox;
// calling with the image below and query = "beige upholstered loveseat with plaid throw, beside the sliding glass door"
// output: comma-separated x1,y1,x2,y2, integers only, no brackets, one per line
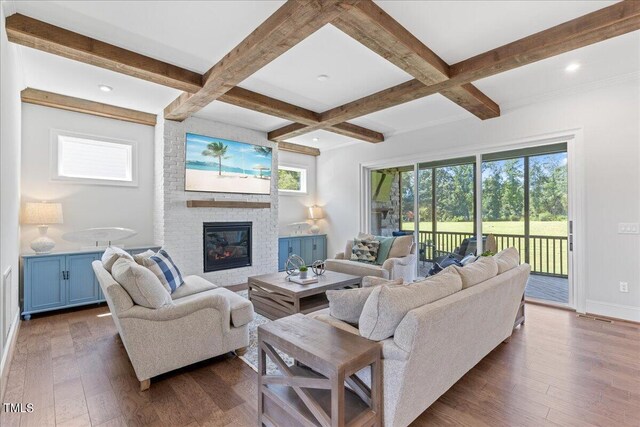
325,236,417,283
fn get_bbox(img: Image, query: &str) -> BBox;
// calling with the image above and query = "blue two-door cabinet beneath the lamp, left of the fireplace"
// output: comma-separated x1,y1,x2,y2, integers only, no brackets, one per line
20,247,159,320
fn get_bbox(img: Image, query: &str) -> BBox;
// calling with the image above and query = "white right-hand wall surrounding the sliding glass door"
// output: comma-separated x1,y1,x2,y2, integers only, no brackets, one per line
318,76,640,321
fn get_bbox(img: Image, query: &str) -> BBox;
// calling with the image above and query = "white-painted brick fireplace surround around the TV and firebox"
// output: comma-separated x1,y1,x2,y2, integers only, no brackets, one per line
154,117,278,286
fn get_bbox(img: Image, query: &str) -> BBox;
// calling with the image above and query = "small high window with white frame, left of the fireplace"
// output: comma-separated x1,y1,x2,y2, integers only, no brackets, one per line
51,132,137,186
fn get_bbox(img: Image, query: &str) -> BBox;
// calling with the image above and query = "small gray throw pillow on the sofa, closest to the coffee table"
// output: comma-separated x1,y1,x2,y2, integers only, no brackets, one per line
326,276,402,325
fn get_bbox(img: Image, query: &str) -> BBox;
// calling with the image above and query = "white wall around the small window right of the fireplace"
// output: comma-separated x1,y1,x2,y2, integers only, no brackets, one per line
278,151,324,235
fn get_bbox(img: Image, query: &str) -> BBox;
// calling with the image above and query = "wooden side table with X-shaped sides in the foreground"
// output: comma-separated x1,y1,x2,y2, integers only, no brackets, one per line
258,314,382,427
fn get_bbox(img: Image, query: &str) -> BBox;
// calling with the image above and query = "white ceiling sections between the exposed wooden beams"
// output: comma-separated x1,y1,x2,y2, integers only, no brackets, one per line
9,1,640,149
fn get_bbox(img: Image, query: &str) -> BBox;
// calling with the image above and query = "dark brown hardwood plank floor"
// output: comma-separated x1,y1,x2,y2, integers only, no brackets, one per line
0,305,640,427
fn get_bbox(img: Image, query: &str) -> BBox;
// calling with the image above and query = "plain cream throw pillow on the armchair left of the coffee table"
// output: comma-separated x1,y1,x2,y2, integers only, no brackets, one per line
111,259,173,308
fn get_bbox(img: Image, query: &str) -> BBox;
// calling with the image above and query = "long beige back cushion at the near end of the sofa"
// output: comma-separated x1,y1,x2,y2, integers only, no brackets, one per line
358,271,462,341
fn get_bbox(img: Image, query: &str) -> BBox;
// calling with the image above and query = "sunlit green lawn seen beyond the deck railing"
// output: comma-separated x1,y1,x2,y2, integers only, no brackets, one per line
402,221,567,237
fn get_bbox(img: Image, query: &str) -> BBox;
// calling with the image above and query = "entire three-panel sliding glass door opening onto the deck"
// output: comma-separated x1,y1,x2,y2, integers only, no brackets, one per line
368,143,571,304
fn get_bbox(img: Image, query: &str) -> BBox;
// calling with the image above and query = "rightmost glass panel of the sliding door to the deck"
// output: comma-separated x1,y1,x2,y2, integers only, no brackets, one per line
482,143,569,304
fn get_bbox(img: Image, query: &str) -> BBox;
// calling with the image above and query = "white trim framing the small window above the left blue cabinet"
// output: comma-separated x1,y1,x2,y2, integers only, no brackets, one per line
49,129,138,187
